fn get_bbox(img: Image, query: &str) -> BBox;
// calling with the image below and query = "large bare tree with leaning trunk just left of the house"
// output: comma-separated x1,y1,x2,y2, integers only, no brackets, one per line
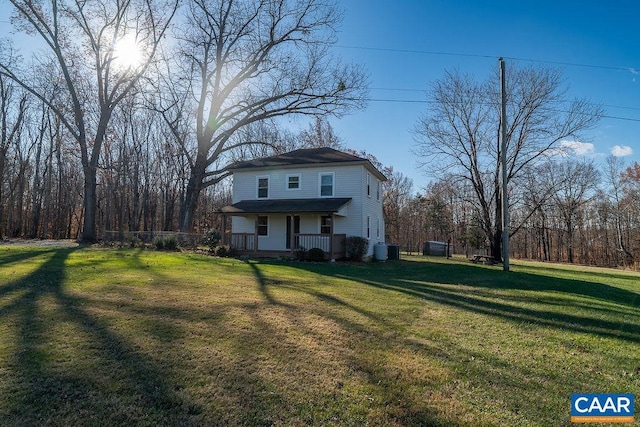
158,0,366,231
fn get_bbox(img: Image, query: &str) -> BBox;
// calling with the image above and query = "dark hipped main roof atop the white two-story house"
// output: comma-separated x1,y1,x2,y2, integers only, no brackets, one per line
229,147,386,181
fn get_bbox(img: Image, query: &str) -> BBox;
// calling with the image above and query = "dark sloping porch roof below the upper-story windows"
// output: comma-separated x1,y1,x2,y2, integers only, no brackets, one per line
220,197,351,216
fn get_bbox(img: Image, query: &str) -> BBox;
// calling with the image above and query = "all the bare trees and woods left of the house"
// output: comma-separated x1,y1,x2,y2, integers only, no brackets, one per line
0,0,366,242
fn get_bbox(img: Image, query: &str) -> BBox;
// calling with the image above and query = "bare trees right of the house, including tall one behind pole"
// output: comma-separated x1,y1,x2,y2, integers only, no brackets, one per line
386,66,640,267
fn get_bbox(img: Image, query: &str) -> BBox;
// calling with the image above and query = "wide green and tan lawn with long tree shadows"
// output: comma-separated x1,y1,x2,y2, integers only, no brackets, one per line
0,247,640,426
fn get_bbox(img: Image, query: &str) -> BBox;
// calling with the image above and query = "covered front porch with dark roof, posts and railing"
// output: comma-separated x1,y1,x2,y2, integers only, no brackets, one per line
219,198,351,259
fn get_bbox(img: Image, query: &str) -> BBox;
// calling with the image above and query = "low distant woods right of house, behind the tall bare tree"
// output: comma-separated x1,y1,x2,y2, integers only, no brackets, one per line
384,157,640,269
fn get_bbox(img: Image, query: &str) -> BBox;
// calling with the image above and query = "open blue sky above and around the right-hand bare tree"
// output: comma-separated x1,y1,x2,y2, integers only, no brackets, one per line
331,0,640,191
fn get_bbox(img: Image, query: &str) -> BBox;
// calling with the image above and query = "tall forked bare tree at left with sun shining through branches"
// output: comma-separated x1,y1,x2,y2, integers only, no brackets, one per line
0,0,177,241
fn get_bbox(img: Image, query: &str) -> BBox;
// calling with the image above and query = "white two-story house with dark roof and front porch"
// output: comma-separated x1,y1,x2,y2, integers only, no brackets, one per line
221,148,386,258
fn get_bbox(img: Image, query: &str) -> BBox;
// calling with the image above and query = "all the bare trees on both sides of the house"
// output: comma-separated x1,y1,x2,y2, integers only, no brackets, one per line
0,0,640,265
